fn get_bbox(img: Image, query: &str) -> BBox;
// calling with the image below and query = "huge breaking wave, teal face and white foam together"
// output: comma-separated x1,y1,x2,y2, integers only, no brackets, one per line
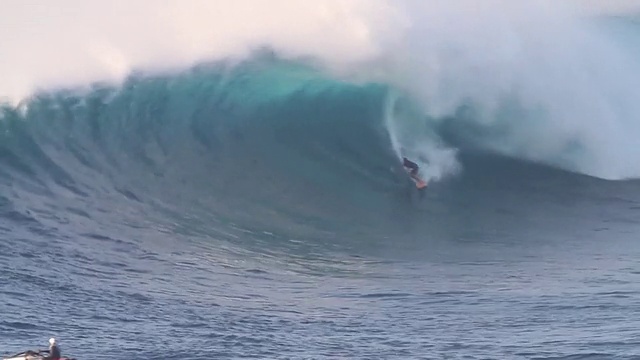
0,2,640,242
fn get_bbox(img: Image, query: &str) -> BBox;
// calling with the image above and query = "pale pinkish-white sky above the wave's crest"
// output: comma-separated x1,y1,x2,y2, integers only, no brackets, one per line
0,0,640,99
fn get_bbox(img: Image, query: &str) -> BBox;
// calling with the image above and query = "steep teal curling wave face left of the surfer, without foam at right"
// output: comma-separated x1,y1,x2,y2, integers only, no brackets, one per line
2,55,416,242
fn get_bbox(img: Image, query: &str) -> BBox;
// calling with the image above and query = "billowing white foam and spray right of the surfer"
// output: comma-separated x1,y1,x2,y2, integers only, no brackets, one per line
376,0,640,179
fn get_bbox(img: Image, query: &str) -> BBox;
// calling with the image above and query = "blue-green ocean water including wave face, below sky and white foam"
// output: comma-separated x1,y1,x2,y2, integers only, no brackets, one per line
0,5,640,360
